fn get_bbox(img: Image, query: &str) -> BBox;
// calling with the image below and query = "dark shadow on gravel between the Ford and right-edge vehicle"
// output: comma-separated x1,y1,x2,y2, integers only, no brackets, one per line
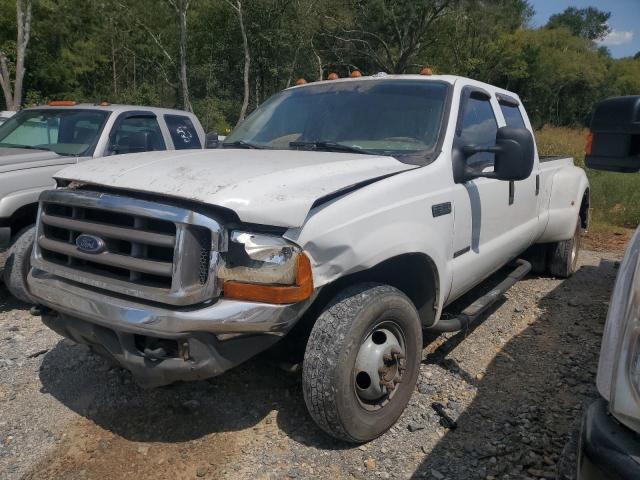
412,260,616,480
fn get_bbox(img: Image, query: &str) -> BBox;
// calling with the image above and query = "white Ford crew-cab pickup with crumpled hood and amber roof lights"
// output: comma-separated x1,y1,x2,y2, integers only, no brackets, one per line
28,75,589,442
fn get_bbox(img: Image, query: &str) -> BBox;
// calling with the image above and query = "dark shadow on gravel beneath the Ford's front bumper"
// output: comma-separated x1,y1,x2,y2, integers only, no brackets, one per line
40,339,314,442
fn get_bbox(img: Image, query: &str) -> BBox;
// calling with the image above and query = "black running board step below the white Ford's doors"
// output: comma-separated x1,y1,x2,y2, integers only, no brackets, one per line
426,259,531,332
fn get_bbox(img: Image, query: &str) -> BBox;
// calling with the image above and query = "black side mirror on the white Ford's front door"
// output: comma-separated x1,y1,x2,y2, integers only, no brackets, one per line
453,127,535,183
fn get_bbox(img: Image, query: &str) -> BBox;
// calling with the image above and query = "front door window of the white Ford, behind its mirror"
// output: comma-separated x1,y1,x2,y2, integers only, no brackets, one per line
458,94,498,166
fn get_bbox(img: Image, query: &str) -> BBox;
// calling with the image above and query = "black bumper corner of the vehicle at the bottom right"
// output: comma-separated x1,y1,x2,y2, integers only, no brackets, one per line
578,398,640,480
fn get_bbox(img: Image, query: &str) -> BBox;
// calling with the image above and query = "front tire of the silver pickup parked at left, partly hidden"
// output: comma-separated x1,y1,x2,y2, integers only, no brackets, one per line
4,226,36,304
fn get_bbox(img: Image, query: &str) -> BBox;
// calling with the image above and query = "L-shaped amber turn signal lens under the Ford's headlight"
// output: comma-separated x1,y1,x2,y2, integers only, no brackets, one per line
222,253,313,305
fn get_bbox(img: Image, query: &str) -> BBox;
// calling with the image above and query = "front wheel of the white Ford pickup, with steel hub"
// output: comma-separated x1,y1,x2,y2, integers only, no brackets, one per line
302,283,422,443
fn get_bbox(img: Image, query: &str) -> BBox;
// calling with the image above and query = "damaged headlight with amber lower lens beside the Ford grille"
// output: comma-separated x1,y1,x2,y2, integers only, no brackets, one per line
218,231,313,304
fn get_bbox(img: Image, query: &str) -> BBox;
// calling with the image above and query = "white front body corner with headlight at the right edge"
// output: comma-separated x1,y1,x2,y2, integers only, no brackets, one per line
597,229,640,431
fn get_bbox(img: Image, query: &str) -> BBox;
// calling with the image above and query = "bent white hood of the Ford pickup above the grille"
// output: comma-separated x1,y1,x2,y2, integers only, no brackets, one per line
56,149,415,227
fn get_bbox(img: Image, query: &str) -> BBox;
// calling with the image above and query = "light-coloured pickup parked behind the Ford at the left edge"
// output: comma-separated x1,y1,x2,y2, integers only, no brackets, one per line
0,100,205,302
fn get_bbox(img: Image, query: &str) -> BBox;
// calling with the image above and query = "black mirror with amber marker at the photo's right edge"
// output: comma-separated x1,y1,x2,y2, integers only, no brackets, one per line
585,95,640,173
